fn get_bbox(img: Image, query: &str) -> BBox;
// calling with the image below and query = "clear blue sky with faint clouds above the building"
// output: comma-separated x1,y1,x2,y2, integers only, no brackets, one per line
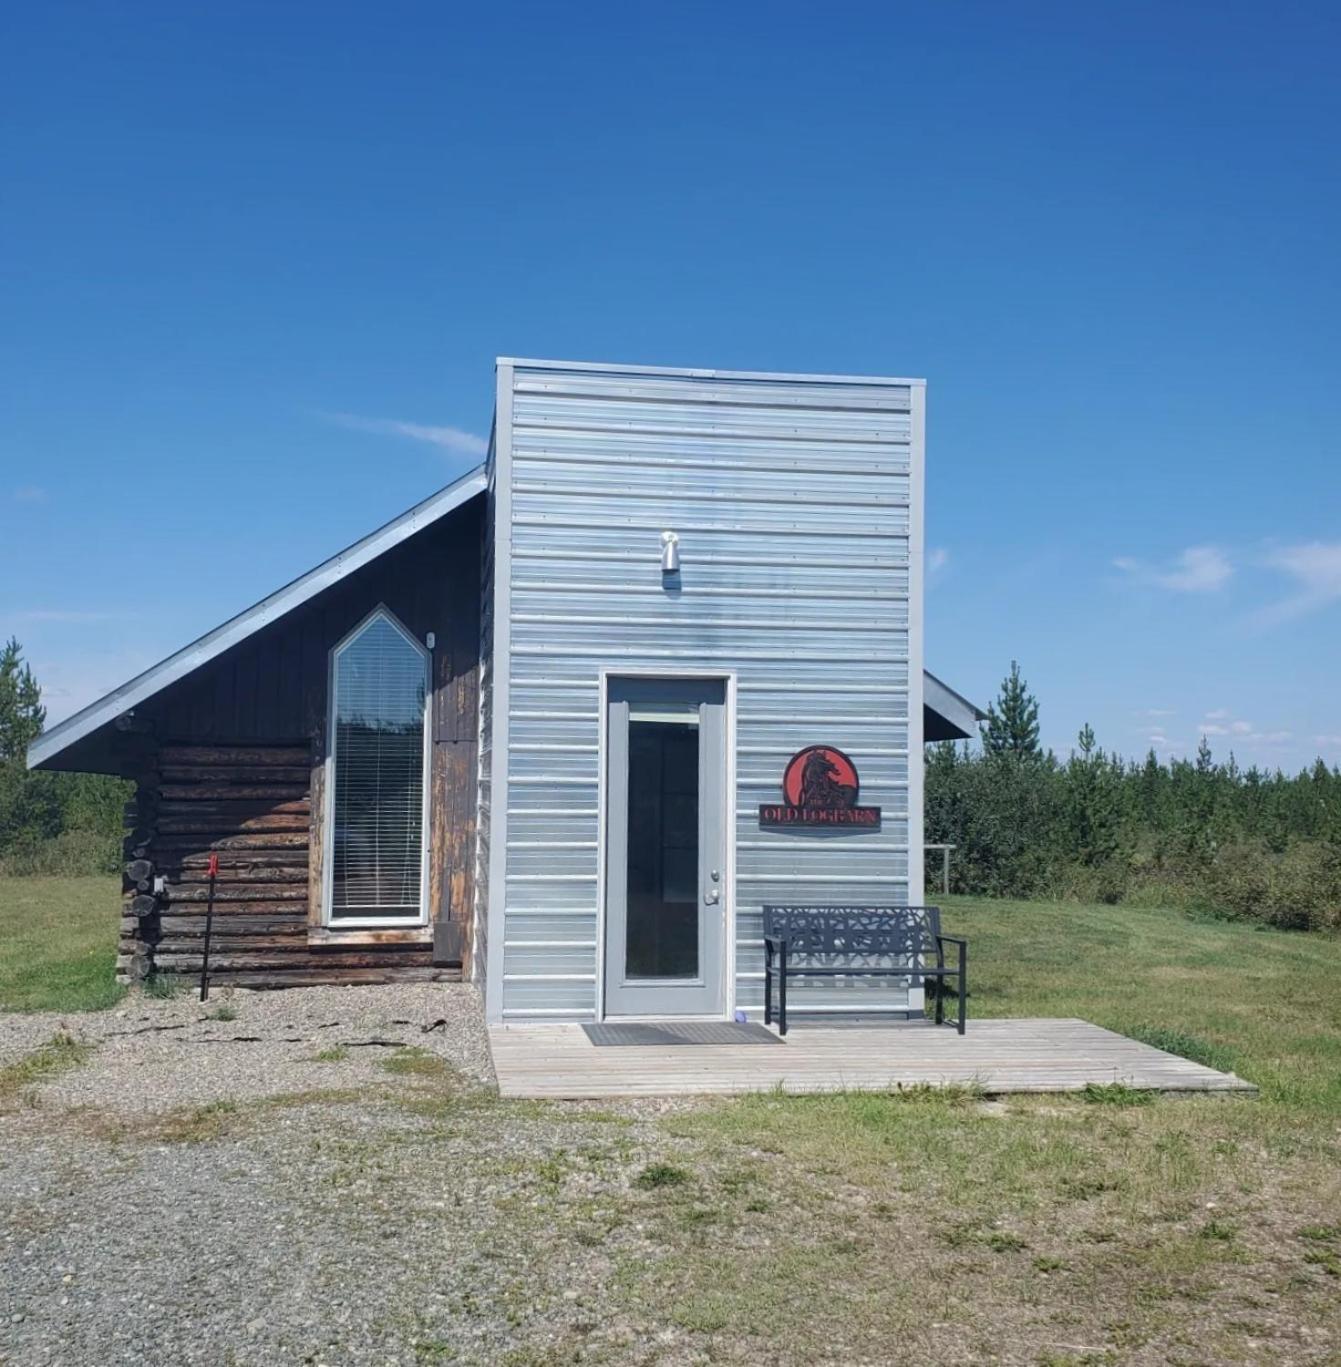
0,3,1341,768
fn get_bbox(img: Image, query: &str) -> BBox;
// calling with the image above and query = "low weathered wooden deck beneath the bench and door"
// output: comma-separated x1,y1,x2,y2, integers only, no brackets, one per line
489,1020,1256,1099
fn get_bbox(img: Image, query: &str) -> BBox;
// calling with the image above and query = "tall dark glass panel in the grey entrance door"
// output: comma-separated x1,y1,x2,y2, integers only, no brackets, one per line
625,707,699,977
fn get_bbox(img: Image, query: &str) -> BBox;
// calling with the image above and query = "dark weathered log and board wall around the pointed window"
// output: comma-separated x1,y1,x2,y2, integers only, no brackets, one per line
118,499,483,987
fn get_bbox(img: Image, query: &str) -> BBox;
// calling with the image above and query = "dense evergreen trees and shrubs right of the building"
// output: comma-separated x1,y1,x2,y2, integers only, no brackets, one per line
925,660,1341,930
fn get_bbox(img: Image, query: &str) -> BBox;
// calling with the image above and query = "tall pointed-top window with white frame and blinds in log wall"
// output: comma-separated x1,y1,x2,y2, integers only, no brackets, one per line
325,608,428,925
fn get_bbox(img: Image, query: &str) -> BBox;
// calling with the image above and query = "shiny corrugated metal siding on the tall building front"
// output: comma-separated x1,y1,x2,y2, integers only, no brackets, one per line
492,362,921,1018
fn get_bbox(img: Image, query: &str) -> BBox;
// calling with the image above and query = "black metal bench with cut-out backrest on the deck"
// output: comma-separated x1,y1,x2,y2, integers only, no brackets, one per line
764,906,968,1035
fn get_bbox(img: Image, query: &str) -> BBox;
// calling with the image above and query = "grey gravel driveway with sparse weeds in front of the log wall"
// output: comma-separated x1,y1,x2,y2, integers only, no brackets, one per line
0,984,699,1367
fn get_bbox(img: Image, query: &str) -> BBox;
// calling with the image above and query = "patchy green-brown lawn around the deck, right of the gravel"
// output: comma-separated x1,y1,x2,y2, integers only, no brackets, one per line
637,898,1341,1363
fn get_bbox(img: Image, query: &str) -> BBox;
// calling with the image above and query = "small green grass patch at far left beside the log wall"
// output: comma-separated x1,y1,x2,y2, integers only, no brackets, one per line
0,875,126,1012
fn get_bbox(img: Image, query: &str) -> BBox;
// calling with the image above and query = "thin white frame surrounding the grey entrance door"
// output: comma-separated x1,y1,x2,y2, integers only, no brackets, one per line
596,664,737,1021
